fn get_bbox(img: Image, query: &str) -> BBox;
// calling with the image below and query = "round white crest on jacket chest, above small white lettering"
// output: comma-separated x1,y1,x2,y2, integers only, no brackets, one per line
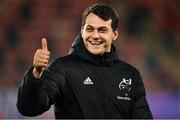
119,78,132,92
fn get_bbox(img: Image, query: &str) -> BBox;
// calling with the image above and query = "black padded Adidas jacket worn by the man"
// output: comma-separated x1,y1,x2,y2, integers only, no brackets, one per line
17,35,152,118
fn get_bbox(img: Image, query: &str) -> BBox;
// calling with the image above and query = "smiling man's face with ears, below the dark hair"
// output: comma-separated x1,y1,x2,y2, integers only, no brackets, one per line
81,13,118,55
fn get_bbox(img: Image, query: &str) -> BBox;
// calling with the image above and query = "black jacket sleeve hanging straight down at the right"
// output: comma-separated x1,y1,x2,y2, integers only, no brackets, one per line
132,71,153,119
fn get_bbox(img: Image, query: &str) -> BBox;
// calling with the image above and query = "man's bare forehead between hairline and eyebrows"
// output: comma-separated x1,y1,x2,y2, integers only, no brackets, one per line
84,13,112,28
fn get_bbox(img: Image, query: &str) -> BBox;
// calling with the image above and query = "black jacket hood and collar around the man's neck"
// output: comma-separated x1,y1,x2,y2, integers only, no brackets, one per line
69,34,118,65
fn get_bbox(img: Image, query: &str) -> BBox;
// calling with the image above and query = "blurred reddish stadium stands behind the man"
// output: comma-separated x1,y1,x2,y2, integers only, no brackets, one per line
0,0,180,119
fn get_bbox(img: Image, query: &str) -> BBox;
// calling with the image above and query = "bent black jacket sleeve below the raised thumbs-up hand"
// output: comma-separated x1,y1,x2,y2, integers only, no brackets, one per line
17,60,65,117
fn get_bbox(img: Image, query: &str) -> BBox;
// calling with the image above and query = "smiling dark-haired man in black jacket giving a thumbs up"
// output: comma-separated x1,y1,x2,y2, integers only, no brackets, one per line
17,4,152,118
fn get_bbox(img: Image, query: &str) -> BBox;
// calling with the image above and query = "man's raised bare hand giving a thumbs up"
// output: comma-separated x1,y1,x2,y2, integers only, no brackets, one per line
33,38,50,78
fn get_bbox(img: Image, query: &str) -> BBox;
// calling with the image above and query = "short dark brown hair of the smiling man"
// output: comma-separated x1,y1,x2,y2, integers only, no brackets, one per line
81,4,119,31
